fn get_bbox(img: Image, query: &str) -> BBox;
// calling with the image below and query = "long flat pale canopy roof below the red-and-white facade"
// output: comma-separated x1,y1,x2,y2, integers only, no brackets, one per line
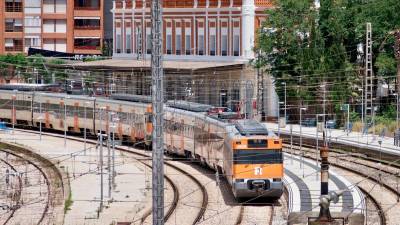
63,59,245,71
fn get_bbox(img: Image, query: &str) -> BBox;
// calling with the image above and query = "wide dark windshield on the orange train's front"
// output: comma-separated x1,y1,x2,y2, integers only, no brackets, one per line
233,149,283,164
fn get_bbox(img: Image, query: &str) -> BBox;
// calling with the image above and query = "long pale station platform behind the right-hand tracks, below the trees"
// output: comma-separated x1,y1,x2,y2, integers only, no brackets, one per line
264,123,400,155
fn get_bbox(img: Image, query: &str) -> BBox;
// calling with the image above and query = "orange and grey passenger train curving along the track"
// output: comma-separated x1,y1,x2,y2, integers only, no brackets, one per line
0,90,284,199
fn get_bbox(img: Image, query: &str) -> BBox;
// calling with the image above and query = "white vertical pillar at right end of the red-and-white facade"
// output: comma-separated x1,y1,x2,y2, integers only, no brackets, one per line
242,0,256,59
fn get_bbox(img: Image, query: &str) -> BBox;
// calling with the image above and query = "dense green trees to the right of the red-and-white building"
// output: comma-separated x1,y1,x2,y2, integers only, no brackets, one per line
255,0,400,119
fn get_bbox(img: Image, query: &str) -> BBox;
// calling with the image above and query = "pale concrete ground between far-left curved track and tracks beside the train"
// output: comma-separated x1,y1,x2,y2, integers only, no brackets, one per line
0,131,151,225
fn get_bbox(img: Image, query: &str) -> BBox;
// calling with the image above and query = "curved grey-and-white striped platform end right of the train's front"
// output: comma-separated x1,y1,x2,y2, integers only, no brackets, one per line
284,154,365,214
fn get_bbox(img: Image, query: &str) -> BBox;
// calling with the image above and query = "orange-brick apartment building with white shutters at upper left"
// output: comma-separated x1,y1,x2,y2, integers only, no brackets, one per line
0,0,104,54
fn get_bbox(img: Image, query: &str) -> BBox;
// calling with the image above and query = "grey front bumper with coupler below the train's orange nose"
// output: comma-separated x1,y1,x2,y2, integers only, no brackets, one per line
233,179,283,198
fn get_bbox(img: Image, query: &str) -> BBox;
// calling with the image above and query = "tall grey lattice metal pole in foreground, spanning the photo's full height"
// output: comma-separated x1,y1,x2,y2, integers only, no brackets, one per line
151,0,164,225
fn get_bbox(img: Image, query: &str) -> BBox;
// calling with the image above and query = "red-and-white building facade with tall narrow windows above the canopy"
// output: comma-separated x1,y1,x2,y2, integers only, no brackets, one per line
112,0,272,61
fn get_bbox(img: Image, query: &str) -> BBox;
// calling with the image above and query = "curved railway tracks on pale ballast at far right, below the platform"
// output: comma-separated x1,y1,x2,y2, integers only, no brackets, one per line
284,145,400,225
